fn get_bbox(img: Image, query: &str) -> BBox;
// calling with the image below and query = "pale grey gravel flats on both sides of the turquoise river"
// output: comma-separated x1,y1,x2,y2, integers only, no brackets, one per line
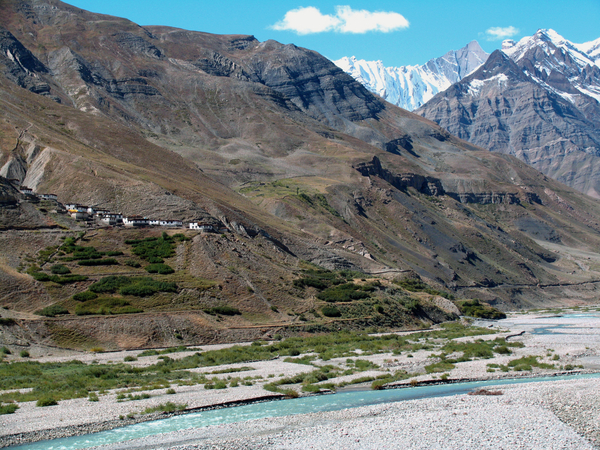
0,313,600,449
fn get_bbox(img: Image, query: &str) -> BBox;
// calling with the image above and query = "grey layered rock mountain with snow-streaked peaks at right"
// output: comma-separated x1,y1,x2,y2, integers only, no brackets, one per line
416,30,600,198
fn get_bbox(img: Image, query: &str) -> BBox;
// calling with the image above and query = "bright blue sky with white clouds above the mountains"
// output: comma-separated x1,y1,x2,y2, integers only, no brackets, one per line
67,0,600,66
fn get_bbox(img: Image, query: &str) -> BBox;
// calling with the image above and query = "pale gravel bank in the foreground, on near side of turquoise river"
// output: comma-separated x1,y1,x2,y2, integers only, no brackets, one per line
96,379,600,450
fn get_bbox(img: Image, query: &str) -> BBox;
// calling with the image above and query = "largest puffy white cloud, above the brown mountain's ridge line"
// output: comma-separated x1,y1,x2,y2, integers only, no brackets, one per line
271,6,409,34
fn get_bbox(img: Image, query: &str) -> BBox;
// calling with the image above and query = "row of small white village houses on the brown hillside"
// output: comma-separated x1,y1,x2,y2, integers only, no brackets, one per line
9,180,227,233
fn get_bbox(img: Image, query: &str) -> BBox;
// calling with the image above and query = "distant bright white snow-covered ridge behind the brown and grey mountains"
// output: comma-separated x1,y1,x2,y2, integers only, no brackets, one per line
333,41,489,111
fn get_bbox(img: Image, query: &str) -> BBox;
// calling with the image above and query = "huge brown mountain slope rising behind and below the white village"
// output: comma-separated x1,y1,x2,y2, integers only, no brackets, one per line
0,0,600,348
